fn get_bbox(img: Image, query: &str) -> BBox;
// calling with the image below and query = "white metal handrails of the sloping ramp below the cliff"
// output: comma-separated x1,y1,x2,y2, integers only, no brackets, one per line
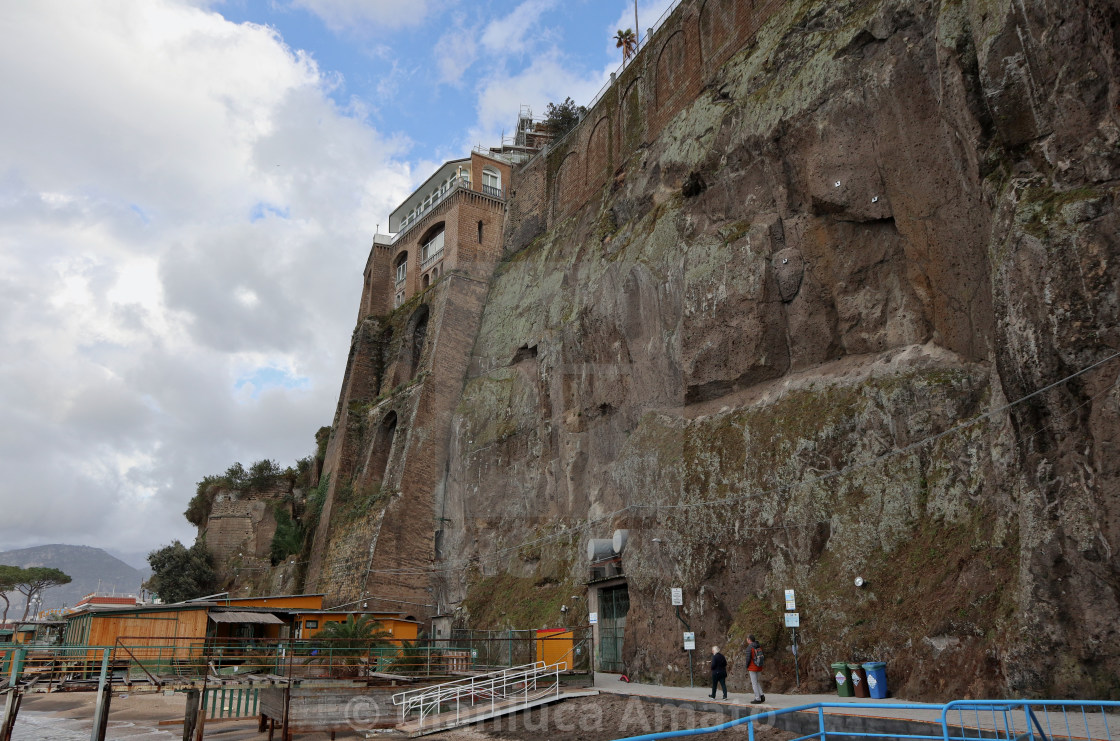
393,662,567,729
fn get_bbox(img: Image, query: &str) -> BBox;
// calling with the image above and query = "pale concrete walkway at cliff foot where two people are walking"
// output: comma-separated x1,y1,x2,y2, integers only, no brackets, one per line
595,673,1120,740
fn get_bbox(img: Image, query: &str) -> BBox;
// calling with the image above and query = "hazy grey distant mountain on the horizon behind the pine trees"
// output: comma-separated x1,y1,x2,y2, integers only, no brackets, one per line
0,545,148,620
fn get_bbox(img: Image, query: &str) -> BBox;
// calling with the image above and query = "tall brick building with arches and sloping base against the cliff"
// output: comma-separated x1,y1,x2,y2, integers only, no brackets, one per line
307,151,512,618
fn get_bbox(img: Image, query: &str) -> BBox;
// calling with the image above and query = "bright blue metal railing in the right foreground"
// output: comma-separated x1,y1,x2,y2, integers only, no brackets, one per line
616,700,1120,741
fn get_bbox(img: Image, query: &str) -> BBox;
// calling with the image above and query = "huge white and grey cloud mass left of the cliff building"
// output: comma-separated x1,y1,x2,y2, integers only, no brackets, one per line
0,0,414,551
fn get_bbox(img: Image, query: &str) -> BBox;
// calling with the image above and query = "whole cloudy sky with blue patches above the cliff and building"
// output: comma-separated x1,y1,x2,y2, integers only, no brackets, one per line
0,0,671,562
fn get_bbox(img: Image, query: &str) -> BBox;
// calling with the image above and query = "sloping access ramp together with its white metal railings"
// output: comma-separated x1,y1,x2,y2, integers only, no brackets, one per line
393,662,598,737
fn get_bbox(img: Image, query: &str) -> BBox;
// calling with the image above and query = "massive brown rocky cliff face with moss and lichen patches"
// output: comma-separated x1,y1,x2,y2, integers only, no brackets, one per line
436,0,1120,698
